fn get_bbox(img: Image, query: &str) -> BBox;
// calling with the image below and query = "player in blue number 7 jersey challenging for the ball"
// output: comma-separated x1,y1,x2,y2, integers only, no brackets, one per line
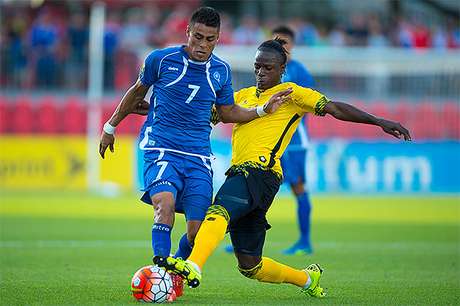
99,7,290,282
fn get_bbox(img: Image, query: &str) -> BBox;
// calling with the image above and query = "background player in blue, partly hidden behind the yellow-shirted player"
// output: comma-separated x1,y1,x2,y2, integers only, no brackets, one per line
272,26,314,255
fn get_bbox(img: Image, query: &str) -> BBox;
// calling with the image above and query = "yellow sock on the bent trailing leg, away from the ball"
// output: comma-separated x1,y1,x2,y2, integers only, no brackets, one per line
239,257,308,288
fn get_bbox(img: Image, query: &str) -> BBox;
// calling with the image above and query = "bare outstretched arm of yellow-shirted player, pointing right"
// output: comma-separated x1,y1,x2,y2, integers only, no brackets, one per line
324,101,412,141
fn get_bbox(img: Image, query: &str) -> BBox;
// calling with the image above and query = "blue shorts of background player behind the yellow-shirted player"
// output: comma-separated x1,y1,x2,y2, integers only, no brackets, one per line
281,150,307,185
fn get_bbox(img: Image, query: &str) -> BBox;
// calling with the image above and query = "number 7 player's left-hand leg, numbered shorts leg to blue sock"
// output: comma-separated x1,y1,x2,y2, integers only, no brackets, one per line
141,151,182,262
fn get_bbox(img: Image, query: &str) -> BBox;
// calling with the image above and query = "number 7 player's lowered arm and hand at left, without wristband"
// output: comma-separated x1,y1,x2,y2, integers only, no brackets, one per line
99,80,149,158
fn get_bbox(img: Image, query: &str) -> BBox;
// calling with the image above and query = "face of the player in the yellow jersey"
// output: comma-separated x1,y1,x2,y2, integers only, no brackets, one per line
254,51,285,90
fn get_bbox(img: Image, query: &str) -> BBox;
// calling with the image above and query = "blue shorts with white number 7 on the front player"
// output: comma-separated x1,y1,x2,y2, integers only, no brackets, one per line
141,150,212,221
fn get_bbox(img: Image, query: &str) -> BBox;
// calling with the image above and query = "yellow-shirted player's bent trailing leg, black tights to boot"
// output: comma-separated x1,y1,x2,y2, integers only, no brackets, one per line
230,209,324,297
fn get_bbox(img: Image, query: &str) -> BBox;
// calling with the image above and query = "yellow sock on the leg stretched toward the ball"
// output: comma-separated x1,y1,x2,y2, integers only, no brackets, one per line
188,205,229,269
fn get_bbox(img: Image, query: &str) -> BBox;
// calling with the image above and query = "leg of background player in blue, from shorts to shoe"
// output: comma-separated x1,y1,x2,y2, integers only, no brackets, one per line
282,150,312,255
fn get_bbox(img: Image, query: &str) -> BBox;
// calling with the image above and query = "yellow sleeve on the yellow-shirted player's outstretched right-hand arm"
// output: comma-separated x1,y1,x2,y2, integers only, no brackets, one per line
293,86,329,116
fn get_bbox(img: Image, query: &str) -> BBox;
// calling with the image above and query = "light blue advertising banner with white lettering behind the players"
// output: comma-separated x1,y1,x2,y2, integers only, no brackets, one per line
138,139,460,193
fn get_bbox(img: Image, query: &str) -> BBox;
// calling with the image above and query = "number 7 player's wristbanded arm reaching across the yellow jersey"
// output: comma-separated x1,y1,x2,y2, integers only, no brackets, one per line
216,88,292,123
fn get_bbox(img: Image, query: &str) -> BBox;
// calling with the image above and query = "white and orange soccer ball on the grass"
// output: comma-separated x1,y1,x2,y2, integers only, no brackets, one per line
131,266,174,303
